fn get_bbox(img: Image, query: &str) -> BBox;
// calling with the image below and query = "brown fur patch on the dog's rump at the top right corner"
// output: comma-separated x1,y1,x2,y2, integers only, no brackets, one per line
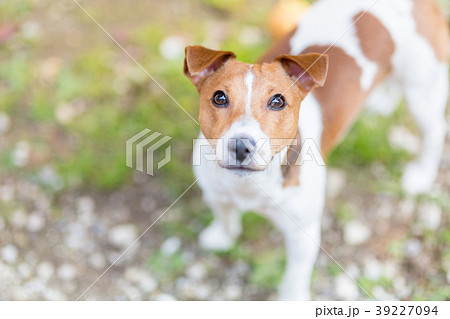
413,0,449,62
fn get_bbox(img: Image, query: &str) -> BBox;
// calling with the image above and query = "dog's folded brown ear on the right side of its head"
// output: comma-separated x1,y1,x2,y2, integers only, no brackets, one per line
275,53,328,92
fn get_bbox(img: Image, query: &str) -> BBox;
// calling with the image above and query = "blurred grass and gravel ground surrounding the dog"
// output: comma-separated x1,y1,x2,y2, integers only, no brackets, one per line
0,0,450,300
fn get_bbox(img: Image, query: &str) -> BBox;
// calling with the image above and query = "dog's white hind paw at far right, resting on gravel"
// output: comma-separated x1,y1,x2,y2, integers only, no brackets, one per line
402,162,435,195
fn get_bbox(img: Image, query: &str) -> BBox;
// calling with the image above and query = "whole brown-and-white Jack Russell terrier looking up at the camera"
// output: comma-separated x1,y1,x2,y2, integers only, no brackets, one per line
184,0,449,300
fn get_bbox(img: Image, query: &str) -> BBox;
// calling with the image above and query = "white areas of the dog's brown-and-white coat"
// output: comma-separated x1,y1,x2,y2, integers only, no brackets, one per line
194,0,448,300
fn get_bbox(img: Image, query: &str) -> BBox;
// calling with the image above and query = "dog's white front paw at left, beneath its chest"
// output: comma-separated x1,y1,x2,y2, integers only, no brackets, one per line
199,221,234,251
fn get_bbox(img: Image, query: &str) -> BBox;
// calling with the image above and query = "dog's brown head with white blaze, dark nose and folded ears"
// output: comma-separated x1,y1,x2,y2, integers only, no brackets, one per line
184,46,328,172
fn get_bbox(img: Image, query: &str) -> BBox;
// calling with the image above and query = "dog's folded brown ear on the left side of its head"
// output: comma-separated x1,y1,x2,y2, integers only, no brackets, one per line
184,45,236,90
